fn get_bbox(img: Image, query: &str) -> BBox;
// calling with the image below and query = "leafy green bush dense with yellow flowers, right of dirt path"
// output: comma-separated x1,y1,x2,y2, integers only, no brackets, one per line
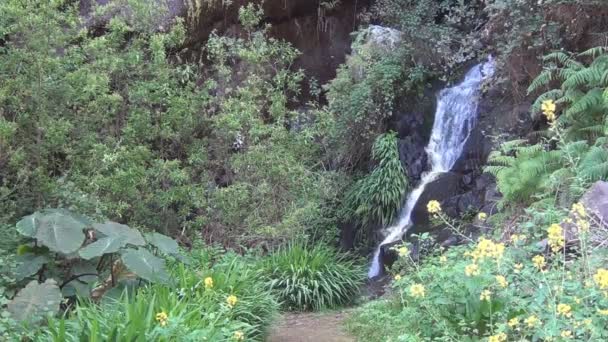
349,205,608,341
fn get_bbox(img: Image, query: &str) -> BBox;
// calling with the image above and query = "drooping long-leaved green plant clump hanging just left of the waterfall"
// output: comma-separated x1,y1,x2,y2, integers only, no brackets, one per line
344,133,407,225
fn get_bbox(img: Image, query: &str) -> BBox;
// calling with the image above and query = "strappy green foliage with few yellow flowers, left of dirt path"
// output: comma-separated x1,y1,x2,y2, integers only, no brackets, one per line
47,249,278,341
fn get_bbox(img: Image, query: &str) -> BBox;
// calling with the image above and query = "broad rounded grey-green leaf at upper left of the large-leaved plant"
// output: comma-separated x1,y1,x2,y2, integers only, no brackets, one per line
36,211,86,254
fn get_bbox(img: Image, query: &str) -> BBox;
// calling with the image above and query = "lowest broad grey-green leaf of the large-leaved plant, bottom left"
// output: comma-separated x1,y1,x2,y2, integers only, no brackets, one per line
7,279,62,323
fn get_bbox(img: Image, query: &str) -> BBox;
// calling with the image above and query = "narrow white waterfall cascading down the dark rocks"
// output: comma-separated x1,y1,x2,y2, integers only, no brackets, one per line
368,57,494,278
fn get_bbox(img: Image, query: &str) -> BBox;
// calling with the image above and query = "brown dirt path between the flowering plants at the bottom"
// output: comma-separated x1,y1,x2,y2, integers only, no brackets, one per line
267,311,355,342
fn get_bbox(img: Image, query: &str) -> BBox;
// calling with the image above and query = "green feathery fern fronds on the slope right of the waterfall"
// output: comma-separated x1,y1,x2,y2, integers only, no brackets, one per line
486,48,608,205
